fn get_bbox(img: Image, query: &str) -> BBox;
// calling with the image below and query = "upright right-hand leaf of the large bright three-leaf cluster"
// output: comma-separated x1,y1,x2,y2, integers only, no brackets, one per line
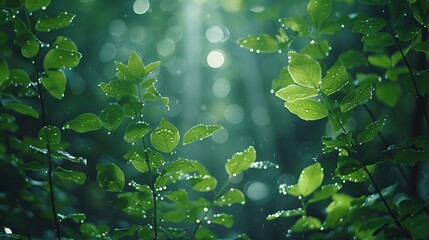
320,61,349,96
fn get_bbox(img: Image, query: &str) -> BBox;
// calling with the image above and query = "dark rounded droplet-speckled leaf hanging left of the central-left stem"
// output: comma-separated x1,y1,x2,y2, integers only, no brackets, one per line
97,163,125,192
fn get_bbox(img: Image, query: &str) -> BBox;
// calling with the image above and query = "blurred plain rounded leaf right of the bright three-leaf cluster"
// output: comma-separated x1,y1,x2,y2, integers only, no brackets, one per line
375,82,401,108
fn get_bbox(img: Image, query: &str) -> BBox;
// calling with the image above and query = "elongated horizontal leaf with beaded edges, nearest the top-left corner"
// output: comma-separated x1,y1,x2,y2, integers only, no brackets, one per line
35,12,76,32
